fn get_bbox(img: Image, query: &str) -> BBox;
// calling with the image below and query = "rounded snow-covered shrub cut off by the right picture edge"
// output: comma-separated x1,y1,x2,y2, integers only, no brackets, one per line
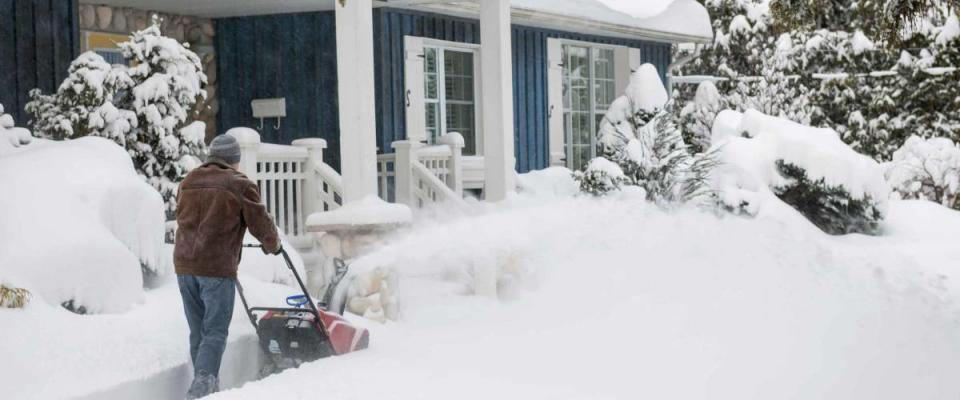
885,136,960,209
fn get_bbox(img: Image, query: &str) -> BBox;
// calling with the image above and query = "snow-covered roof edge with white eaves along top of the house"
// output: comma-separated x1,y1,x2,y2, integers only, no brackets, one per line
80,0,713,42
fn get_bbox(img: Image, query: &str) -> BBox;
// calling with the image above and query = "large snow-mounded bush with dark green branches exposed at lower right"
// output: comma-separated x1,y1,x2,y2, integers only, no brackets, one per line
711,110,890,234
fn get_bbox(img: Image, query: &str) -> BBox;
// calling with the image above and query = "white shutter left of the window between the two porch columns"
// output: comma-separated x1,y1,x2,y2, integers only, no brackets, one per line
403,36,427,142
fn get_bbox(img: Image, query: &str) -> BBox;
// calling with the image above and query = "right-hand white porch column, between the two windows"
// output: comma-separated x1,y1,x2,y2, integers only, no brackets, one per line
479,0,516,201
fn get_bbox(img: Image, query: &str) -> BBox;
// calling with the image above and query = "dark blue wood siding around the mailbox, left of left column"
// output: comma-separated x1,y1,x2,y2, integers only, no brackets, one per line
216,12,340,168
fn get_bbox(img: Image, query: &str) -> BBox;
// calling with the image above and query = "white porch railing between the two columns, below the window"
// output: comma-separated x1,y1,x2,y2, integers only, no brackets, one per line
377,133,463,208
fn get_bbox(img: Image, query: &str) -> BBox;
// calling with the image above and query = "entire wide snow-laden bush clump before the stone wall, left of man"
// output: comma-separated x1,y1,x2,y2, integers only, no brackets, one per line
27,17,207,216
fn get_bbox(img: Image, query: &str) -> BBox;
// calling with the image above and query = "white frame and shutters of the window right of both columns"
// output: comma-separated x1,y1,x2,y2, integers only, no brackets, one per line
547,38,641,167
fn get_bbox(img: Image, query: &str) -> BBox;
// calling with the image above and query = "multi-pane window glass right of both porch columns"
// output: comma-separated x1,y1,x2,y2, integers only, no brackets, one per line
561,44,617,170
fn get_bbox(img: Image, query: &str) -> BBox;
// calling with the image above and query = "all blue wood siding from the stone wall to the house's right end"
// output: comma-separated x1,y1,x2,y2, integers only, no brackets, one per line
215,7,670,172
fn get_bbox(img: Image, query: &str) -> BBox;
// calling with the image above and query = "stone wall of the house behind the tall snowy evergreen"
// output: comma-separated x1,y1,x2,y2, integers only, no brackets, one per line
79,4,219,141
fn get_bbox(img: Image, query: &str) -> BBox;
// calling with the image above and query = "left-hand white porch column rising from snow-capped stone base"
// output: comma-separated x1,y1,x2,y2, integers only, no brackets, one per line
335,0,377,205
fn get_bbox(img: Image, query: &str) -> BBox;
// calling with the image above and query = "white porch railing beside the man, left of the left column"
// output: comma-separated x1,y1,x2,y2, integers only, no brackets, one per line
227,128,343,238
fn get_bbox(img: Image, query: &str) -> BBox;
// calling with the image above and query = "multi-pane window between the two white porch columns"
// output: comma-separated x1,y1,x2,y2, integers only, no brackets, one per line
423,46,477,155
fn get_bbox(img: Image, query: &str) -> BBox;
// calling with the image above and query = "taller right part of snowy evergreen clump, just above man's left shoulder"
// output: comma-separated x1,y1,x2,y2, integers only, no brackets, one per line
120,18,207,213
